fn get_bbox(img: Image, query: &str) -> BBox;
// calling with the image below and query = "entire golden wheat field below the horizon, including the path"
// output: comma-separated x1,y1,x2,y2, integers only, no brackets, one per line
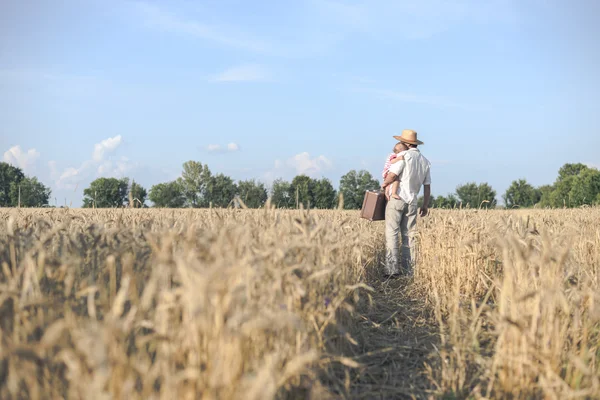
0,208,600,400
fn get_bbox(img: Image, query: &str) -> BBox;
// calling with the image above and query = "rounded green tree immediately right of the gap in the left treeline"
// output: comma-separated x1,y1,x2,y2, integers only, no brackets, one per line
83,178,129,208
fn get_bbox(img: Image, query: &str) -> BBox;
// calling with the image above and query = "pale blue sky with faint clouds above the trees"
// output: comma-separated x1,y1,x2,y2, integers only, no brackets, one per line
0,0,600,206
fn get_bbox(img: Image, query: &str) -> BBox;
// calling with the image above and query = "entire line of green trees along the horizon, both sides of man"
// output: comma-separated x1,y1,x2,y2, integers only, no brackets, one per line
0,161,600,210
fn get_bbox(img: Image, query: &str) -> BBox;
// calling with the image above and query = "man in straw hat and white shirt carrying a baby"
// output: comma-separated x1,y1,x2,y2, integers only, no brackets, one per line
381,129,431,278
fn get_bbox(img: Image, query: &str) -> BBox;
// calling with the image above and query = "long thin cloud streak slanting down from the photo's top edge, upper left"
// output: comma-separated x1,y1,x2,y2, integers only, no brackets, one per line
135,1,269,53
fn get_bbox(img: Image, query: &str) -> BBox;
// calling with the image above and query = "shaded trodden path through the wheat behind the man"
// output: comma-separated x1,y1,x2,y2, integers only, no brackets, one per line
322,271,438,400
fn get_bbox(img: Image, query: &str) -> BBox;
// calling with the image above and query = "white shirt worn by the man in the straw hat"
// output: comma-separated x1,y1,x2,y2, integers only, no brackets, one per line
389,149,431,204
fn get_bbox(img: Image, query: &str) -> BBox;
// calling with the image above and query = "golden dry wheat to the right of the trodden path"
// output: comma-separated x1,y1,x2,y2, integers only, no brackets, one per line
414,208,600,399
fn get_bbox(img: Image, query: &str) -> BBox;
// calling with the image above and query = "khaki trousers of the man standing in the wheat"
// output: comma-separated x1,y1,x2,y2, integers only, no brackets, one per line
384,197,419,275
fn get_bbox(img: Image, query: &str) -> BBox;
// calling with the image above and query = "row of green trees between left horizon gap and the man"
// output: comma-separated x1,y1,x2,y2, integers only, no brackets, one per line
113,161,379,209
